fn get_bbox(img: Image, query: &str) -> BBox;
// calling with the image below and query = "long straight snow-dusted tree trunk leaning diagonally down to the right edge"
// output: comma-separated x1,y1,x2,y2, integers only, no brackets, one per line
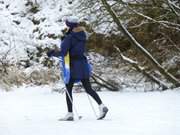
101,0,180,87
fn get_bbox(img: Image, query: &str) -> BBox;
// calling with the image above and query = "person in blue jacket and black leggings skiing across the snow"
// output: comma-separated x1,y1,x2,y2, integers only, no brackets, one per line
48,16,108,121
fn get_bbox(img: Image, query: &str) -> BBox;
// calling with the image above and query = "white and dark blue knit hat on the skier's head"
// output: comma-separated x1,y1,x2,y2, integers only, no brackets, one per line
65,16,79,29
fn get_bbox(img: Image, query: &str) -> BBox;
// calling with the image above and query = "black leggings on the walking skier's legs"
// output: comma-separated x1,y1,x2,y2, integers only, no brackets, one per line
66,79,102,112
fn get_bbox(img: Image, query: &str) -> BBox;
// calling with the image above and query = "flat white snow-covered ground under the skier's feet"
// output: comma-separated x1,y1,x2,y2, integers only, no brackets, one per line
0,87,180,135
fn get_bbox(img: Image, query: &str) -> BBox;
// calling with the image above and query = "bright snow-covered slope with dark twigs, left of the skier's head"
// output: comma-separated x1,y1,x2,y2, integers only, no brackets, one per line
0,0,73,62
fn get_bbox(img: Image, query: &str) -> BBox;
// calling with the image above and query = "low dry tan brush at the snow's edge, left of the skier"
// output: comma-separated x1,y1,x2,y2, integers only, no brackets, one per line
0,66,60,91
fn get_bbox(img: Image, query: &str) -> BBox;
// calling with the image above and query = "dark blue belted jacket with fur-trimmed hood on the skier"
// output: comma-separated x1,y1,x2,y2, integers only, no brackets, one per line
60,27,91,80
